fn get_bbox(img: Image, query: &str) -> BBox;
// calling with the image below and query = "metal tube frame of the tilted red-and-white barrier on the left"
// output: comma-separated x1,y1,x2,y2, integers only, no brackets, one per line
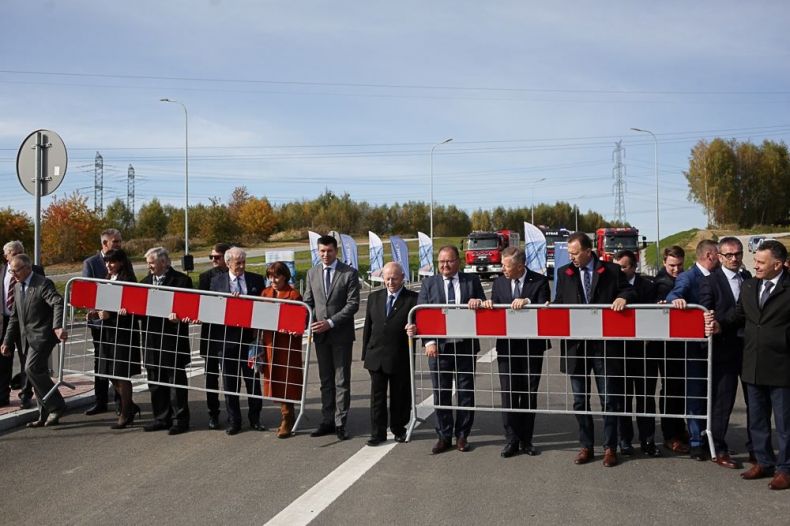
44,277,313,433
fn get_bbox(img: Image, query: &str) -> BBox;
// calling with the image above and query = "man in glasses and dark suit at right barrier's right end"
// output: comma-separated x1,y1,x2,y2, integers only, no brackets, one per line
699,237,754,469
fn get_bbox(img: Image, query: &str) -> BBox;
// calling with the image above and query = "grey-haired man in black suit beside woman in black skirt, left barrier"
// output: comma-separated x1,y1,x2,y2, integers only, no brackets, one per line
141,247,192,435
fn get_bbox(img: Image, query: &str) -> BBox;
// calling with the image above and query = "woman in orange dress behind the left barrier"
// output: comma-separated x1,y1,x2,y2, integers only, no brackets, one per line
261,261,307,438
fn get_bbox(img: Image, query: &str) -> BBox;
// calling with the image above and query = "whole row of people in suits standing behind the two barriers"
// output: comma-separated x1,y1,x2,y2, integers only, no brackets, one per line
0,229,790,489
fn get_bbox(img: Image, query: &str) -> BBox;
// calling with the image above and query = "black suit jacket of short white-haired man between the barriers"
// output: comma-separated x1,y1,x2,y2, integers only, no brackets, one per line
362,287,417,375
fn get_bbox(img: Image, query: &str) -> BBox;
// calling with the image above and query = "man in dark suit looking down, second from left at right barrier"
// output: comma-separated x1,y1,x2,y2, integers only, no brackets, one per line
483,247,551,458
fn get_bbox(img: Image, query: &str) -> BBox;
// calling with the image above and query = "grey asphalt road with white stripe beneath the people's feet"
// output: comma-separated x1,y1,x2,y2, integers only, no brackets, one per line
0,276,790,525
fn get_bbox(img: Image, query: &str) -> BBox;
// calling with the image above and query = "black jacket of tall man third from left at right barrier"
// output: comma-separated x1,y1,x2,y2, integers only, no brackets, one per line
554,256,637,374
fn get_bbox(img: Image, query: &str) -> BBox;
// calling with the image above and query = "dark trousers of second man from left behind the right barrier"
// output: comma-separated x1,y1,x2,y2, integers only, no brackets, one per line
497,350,543,445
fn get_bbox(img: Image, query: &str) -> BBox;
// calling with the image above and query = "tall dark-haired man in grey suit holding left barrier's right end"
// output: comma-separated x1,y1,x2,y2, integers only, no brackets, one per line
304,236,359,440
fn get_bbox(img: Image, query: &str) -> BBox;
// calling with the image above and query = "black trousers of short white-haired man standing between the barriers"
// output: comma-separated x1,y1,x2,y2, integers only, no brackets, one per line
368,370,411,439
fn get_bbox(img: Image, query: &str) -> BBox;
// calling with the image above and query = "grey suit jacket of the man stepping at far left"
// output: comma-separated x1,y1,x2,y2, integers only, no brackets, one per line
5,273,63,353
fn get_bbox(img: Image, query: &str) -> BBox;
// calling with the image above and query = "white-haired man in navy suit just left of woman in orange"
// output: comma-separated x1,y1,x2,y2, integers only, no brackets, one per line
209,247,266,435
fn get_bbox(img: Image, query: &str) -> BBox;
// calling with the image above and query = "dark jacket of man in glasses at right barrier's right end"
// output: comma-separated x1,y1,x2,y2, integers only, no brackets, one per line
699,268,752,373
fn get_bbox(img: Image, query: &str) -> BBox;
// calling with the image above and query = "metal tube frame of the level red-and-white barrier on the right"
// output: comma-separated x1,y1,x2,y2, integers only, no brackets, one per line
406,304,716,458
